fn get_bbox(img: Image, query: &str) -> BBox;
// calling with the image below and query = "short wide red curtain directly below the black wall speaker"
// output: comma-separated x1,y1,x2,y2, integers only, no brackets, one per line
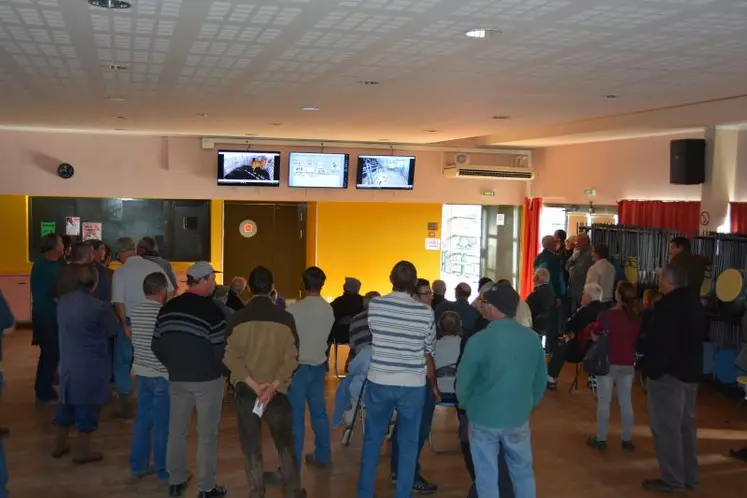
617,201,700,235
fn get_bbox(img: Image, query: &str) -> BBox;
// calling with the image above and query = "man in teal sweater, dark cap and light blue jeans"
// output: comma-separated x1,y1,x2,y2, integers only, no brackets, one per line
456,283,547,498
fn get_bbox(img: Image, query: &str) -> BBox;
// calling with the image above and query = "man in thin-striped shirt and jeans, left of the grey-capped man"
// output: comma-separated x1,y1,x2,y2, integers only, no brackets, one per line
130,272,170,479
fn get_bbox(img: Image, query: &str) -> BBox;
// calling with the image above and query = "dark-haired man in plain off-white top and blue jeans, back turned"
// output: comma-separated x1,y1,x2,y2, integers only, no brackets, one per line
288,266,335,469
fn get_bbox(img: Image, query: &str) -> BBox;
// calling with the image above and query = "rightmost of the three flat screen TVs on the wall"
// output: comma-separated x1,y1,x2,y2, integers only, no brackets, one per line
356,155,415,190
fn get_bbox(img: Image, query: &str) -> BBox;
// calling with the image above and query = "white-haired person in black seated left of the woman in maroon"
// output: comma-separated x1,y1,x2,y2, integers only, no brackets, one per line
547,284,605,391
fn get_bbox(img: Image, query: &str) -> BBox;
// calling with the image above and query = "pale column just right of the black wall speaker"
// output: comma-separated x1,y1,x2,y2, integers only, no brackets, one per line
700,126,747,232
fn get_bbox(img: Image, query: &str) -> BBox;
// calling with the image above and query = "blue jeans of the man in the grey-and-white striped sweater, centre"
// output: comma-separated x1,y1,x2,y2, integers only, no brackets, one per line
357,381,425,498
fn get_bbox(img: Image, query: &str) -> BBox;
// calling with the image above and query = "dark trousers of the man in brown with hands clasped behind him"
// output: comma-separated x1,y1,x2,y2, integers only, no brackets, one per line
236,383,301,498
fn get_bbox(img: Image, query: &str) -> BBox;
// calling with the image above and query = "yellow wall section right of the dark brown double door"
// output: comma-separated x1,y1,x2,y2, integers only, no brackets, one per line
316,202,441,297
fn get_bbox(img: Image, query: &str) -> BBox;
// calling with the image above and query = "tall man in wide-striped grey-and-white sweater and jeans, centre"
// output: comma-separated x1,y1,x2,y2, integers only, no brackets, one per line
358,261,438,498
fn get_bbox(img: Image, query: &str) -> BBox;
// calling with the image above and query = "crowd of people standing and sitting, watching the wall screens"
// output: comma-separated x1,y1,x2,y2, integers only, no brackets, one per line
0,231,705,498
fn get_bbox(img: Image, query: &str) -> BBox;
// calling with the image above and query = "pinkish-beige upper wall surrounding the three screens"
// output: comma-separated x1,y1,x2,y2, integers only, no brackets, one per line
0,132,525,205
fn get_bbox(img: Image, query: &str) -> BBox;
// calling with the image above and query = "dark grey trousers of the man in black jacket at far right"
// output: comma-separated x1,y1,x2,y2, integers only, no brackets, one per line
646,374,698,489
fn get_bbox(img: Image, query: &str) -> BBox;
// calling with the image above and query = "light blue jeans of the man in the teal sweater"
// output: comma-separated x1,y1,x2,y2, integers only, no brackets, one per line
470,422,537,498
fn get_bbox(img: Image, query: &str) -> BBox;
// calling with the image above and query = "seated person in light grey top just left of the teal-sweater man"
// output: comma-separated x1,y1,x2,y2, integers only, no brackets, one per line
433,311,464,404
